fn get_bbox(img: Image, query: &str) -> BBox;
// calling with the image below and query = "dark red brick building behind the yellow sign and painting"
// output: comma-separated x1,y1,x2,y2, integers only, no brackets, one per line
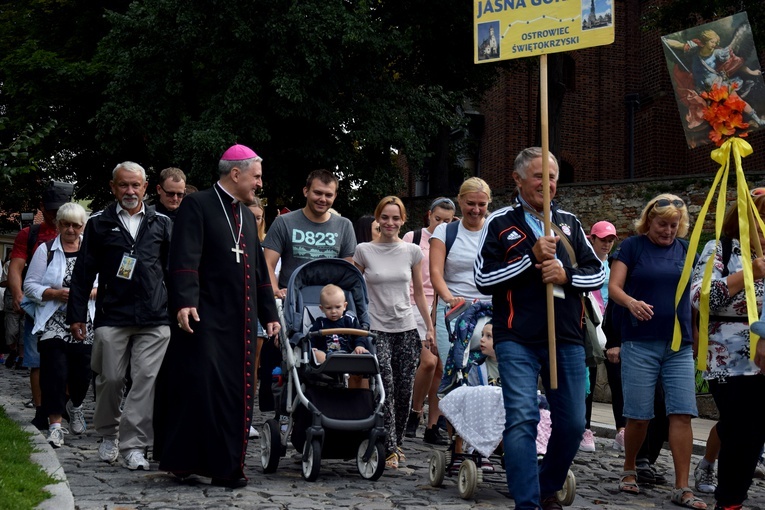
474,0,765,193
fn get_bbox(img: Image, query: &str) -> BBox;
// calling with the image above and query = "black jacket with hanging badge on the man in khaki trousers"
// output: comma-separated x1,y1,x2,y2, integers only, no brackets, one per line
67,202,172,328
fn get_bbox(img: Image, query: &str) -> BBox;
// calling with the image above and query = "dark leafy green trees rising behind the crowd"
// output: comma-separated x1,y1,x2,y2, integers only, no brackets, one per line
0,0,501,221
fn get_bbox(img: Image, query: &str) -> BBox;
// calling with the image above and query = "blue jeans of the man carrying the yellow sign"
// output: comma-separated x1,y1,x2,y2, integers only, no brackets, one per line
494,341,587,510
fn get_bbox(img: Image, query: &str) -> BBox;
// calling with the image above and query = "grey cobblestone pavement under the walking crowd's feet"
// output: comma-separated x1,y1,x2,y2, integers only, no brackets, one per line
0,367,765,510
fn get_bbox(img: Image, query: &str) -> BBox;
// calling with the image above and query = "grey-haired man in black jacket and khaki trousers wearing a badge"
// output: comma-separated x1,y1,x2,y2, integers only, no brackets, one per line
67,161,172,470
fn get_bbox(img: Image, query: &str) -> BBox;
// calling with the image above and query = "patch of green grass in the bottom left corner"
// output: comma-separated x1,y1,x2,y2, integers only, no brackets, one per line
0,407,55,510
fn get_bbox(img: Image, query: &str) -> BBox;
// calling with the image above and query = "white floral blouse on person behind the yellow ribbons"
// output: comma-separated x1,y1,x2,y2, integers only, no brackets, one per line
691,239,763,380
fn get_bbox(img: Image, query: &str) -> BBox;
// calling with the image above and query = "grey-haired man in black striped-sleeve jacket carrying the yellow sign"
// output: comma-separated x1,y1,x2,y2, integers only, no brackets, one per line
474,147,605,510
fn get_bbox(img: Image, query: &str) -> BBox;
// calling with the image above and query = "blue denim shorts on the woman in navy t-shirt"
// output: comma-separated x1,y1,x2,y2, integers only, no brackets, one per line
621,340,698,420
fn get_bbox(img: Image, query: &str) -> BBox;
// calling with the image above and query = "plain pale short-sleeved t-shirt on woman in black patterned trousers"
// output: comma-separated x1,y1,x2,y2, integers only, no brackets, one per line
353,241,422,333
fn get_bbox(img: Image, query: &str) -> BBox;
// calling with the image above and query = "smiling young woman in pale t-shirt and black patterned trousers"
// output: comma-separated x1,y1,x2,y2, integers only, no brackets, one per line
353,196,433,469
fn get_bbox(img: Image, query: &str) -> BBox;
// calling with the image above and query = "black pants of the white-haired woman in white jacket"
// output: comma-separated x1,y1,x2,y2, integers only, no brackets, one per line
38,338,93,416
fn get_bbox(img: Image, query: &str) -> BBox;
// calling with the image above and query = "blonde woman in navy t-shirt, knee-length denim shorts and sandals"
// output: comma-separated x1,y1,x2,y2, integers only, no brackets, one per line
608,193,706,509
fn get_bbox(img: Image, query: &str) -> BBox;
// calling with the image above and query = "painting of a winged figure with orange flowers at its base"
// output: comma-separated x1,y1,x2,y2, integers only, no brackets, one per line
661,12,765,148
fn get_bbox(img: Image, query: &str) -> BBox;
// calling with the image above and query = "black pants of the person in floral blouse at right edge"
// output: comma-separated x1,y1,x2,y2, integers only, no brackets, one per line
709,375,765,505
